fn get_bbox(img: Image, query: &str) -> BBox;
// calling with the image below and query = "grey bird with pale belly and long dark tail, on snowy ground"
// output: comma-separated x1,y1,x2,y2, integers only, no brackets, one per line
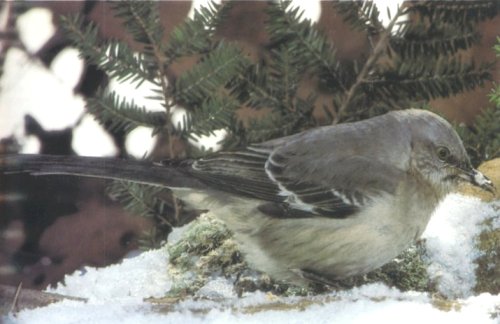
0,109,494,283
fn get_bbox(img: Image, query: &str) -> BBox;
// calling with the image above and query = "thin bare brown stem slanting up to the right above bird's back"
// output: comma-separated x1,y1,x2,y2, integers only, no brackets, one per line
332,7,405,124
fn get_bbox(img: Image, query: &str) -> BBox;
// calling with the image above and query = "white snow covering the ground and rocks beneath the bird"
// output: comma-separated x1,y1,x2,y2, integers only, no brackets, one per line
4,194,500,324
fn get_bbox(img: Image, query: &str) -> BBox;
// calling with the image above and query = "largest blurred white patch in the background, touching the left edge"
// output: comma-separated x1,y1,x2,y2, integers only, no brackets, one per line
0,48,85,139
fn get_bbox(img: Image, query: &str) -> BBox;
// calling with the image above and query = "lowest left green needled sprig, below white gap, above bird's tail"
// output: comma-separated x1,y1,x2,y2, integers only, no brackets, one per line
87,90,167,133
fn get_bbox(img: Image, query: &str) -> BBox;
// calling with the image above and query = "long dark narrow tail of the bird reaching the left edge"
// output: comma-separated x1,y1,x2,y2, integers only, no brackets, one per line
0,154,206,189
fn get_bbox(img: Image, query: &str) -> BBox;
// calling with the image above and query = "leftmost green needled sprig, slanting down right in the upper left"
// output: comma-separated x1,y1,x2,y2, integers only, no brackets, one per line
61,15,159,85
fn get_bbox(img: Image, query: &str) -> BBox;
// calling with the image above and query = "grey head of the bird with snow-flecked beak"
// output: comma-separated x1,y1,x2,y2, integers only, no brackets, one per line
408,111,495,193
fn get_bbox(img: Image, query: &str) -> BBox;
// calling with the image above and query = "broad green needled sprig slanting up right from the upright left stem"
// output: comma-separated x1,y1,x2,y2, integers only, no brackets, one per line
173,43,249,106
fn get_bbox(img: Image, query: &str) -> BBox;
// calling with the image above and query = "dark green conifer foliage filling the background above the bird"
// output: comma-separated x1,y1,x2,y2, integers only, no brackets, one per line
63,1,498,242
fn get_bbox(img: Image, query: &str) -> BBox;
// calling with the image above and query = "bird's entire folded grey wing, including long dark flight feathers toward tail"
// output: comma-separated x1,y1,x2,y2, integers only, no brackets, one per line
190,139,402,218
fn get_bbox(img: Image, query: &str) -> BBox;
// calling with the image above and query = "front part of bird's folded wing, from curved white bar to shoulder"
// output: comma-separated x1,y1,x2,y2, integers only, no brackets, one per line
265,150,404,217
